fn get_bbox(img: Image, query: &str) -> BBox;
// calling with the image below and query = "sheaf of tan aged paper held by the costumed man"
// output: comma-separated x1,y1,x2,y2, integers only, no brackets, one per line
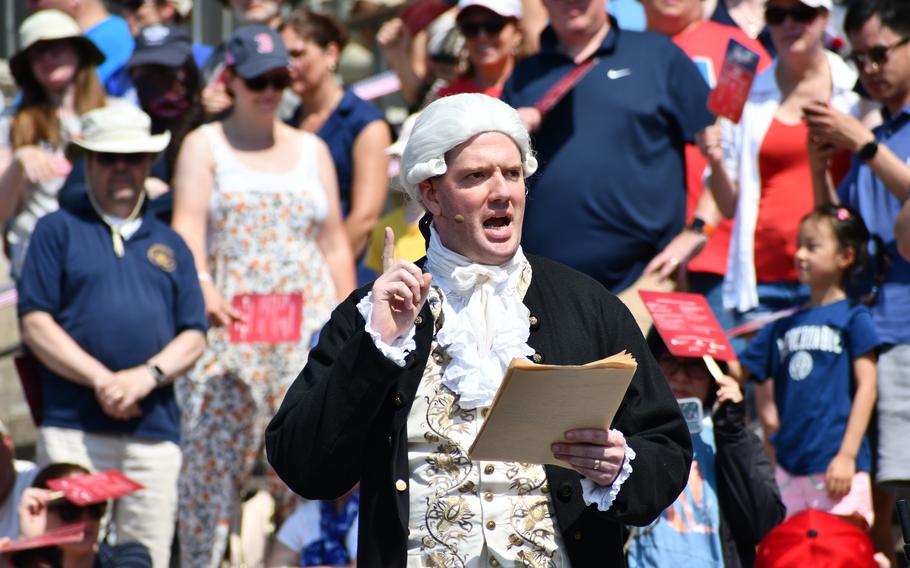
468,352,637,467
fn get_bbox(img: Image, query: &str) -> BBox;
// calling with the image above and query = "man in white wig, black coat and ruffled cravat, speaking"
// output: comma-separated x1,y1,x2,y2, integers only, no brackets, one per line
266,94,691,568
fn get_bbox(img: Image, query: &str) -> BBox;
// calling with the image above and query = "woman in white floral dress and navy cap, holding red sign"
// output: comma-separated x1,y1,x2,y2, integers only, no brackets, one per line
173,26,354,567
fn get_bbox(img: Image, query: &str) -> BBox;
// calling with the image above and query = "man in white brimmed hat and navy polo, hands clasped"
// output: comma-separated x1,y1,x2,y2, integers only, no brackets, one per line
18,105,206,567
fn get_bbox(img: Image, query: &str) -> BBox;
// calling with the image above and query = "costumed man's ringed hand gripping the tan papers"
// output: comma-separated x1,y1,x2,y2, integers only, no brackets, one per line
551,428,626,487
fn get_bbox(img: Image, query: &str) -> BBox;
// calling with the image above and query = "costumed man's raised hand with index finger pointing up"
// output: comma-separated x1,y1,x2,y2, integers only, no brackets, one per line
371,227,432,344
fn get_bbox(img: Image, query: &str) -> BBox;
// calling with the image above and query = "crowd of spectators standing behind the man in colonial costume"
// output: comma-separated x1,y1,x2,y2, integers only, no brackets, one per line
0,0,910,567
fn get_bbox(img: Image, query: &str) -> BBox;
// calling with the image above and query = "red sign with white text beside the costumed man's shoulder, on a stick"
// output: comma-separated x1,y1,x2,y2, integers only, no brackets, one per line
638,290,736,361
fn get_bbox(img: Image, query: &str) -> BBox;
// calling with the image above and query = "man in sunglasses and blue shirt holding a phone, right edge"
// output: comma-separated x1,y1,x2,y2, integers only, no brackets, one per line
804,0,910,562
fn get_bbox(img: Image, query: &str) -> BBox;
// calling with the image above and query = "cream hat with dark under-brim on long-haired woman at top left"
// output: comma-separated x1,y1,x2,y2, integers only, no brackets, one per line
9,10,104,86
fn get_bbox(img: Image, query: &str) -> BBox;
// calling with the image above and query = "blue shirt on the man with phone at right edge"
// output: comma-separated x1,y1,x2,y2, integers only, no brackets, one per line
837,106,910,344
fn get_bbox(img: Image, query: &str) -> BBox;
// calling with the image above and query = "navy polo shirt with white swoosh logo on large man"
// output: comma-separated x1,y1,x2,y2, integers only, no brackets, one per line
502,18,714,291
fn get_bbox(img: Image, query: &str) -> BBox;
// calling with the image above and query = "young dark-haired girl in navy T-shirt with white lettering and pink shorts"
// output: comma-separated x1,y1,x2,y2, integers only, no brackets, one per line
741,205,881,529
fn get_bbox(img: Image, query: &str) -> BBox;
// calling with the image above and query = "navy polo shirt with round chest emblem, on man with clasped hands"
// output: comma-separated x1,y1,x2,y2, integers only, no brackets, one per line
18,197,206,442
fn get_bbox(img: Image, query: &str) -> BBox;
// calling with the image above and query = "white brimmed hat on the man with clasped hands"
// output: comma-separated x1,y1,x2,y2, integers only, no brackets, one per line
70,103,171,154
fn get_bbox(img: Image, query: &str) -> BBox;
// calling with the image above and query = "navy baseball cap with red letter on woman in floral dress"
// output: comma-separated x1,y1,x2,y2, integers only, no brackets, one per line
224,24,290,79
